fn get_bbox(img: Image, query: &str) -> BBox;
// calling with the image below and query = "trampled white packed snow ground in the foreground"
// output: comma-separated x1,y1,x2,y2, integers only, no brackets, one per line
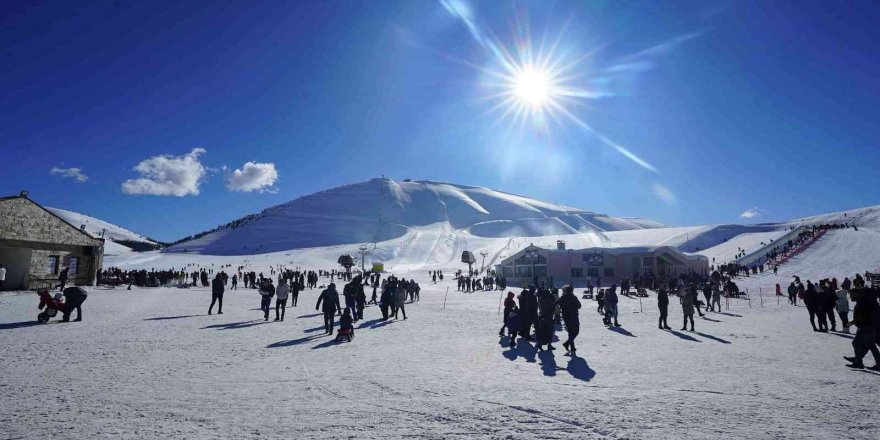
0,263,880,439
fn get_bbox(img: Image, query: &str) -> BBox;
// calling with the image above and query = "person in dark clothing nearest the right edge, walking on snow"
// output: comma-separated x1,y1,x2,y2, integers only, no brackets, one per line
844,288,880,371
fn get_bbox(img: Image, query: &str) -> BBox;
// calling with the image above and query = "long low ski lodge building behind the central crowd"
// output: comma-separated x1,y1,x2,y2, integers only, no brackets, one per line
496,241,709,286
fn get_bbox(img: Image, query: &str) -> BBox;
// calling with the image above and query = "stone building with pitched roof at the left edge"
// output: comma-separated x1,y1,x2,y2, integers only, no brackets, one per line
0,191,104,290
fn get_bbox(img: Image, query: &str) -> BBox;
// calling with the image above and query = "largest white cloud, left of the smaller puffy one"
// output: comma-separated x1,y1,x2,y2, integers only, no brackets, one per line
122,148,207,197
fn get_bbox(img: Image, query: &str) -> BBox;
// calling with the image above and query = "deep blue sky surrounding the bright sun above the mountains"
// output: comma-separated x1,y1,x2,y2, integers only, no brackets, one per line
0,0,880,240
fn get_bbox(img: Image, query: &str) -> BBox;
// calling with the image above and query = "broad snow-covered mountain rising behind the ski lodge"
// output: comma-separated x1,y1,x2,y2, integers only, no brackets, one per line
166,178,663,255
